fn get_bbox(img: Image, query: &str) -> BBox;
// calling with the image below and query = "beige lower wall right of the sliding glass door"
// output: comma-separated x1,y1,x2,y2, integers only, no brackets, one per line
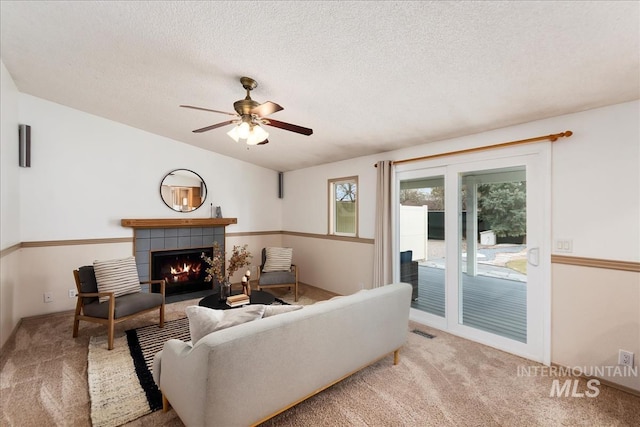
551,264,640,391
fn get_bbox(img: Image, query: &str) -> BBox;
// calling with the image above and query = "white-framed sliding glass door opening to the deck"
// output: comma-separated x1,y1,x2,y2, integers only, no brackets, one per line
394,144,550,362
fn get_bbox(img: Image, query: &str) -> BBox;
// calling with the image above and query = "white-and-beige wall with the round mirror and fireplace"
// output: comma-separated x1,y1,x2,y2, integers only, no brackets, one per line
0,65,283,345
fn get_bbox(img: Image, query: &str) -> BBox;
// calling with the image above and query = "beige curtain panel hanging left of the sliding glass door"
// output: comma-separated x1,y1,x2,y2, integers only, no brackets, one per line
373,160,393,288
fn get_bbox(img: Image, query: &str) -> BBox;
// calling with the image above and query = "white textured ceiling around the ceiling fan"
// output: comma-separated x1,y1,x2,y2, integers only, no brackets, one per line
0,0,640,171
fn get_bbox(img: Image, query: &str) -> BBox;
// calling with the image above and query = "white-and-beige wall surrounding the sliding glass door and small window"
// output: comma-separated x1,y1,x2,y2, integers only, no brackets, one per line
283,101,640,391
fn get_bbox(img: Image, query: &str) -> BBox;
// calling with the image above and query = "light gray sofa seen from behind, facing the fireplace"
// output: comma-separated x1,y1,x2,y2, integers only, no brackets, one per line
153,283,412,426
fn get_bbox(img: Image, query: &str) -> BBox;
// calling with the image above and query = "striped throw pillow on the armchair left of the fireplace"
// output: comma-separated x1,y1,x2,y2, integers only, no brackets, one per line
93,256,140,302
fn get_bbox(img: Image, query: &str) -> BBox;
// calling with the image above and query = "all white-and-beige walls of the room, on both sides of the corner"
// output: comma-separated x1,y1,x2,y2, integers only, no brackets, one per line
0,54,640,390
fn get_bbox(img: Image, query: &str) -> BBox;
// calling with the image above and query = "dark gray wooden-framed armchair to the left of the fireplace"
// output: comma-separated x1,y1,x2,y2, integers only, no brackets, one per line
73,265,165,350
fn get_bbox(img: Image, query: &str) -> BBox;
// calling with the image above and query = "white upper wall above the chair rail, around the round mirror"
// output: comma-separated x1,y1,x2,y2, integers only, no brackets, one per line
19,94,282,242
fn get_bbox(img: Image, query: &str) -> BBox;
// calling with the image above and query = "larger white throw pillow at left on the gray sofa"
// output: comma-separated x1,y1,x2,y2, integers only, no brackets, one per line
184,304,264,345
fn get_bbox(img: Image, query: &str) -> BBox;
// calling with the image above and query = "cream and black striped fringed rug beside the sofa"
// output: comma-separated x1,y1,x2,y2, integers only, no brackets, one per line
88,317,190,427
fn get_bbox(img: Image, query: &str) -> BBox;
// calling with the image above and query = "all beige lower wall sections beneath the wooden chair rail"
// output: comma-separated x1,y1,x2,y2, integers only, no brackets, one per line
5,232,640,391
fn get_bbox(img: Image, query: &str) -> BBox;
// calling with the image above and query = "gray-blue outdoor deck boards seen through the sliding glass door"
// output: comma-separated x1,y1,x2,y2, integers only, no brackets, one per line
411,265,527,342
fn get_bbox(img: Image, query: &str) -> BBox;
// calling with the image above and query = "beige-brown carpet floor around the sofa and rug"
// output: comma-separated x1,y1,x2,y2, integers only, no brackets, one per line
0,284,640,427
